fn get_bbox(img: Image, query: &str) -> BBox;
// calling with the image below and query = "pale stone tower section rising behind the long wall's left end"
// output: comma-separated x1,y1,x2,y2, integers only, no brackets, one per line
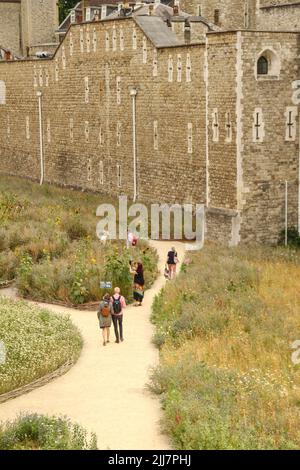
21,0,59,55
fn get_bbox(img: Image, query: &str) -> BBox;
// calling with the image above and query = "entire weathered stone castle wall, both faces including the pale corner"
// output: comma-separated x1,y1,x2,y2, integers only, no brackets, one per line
0,5,300,245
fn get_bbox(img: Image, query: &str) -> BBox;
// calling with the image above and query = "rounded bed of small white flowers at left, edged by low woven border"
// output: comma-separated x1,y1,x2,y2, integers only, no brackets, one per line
0,298,82,395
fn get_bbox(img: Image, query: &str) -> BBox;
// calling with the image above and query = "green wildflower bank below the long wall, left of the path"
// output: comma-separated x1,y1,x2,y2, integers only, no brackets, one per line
0,176,157,305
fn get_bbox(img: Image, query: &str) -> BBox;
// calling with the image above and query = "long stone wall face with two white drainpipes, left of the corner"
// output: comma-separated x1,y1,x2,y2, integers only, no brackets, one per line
0,19,205,203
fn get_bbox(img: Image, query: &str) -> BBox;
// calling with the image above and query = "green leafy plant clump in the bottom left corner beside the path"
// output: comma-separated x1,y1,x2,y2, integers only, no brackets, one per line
0,414,97,450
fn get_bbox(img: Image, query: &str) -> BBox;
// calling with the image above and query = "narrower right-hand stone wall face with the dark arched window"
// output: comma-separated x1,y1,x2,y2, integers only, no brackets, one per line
241,32,300,242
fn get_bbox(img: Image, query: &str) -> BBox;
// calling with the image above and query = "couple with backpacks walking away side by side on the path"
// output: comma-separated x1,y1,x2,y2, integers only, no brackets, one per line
97,287,126,346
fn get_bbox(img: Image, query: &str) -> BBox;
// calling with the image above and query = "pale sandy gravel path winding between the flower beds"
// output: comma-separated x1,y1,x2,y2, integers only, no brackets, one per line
0,242,184,450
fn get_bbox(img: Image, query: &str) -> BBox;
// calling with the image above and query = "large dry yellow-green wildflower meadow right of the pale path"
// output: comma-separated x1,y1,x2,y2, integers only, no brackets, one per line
151,247,300,449
